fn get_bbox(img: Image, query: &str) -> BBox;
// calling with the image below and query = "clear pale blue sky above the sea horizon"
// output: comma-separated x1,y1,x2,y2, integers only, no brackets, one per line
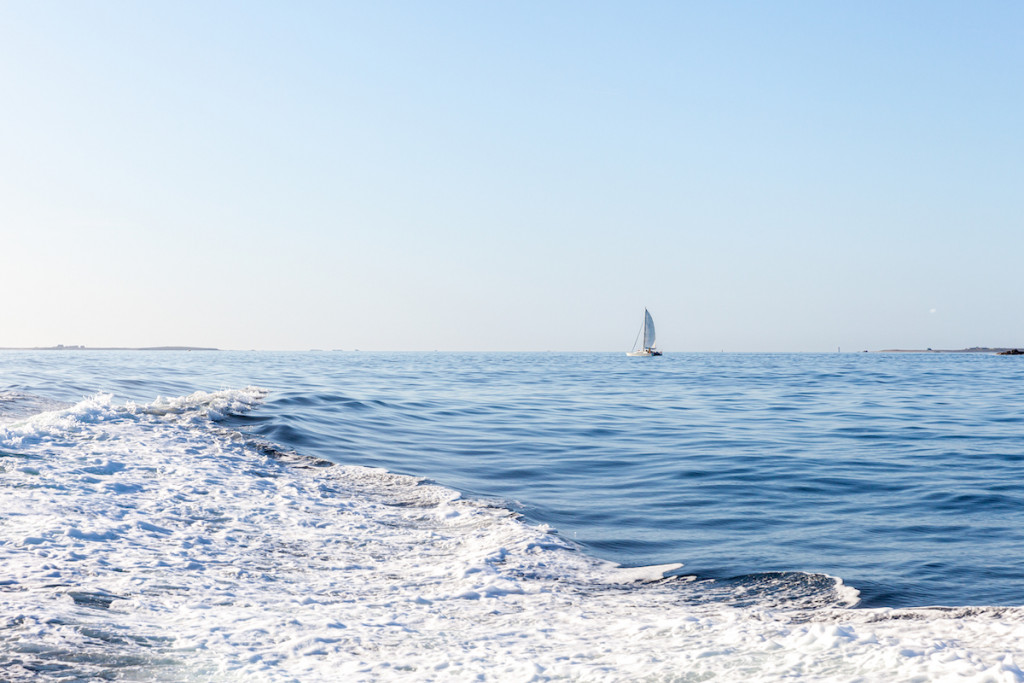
0,0,1024,352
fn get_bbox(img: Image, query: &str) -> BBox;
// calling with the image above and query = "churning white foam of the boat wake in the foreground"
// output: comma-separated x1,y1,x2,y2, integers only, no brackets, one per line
0,388,1024,681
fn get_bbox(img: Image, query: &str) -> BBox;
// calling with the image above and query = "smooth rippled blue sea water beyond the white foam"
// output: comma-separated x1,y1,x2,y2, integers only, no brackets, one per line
0,351,1024,607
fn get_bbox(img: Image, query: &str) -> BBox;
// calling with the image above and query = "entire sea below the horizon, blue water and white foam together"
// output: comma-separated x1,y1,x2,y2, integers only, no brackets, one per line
0,350,1024,681
